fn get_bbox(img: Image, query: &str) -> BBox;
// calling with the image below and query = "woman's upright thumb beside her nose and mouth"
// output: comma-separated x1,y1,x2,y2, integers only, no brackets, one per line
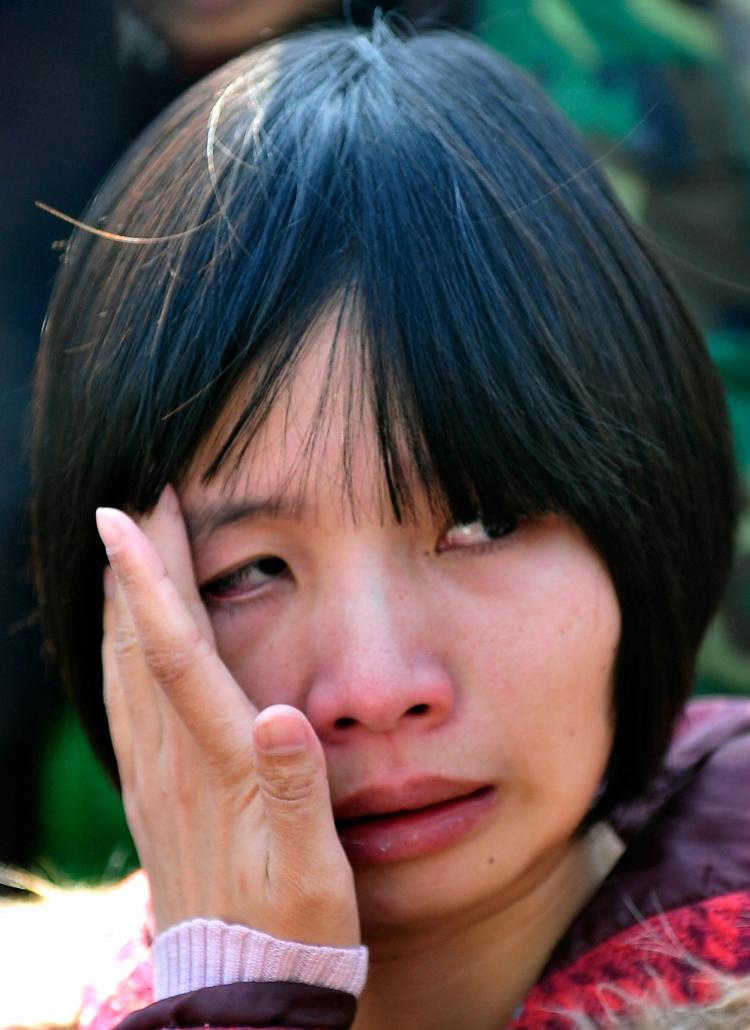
253,705,360,947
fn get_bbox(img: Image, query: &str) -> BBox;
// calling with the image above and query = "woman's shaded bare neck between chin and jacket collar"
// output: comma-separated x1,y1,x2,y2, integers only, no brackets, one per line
354,826,621,1030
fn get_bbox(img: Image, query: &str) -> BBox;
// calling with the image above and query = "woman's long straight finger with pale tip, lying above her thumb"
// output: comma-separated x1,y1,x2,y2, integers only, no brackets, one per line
97,496,254,767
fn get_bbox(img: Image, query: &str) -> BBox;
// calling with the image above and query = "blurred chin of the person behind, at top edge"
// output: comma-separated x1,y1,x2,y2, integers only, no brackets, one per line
131,0,336,67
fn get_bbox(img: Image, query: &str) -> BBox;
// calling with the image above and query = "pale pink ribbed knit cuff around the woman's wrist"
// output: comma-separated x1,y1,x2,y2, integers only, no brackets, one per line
152,919,368,1000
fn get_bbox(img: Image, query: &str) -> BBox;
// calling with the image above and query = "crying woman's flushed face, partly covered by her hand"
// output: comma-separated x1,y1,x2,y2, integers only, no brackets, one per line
180,327,620,932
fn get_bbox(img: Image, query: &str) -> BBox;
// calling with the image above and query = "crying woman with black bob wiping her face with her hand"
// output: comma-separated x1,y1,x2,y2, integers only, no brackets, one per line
34,21,750,1030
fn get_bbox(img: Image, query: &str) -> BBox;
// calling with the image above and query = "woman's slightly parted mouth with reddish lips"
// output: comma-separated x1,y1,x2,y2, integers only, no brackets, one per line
335,784,497,865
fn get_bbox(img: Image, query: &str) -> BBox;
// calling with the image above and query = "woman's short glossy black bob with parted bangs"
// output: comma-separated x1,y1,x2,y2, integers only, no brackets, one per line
33,19,738,812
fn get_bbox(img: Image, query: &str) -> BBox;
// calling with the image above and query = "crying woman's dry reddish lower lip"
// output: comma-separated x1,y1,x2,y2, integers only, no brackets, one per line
338,787,496,865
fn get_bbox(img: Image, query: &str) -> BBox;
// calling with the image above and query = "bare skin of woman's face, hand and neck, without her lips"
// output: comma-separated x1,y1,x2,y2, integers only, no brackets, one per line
100,323,620,1030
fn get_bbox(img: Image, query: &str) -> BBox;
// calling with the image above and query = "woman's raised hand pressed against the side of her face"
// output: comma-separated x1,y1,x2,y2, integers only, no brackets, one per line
97,487,360,947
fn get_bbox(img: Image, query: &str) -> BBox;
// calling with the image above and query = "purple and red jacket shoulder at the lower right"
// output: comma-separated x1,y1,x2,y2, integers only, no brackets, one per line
513,700,750,1030
